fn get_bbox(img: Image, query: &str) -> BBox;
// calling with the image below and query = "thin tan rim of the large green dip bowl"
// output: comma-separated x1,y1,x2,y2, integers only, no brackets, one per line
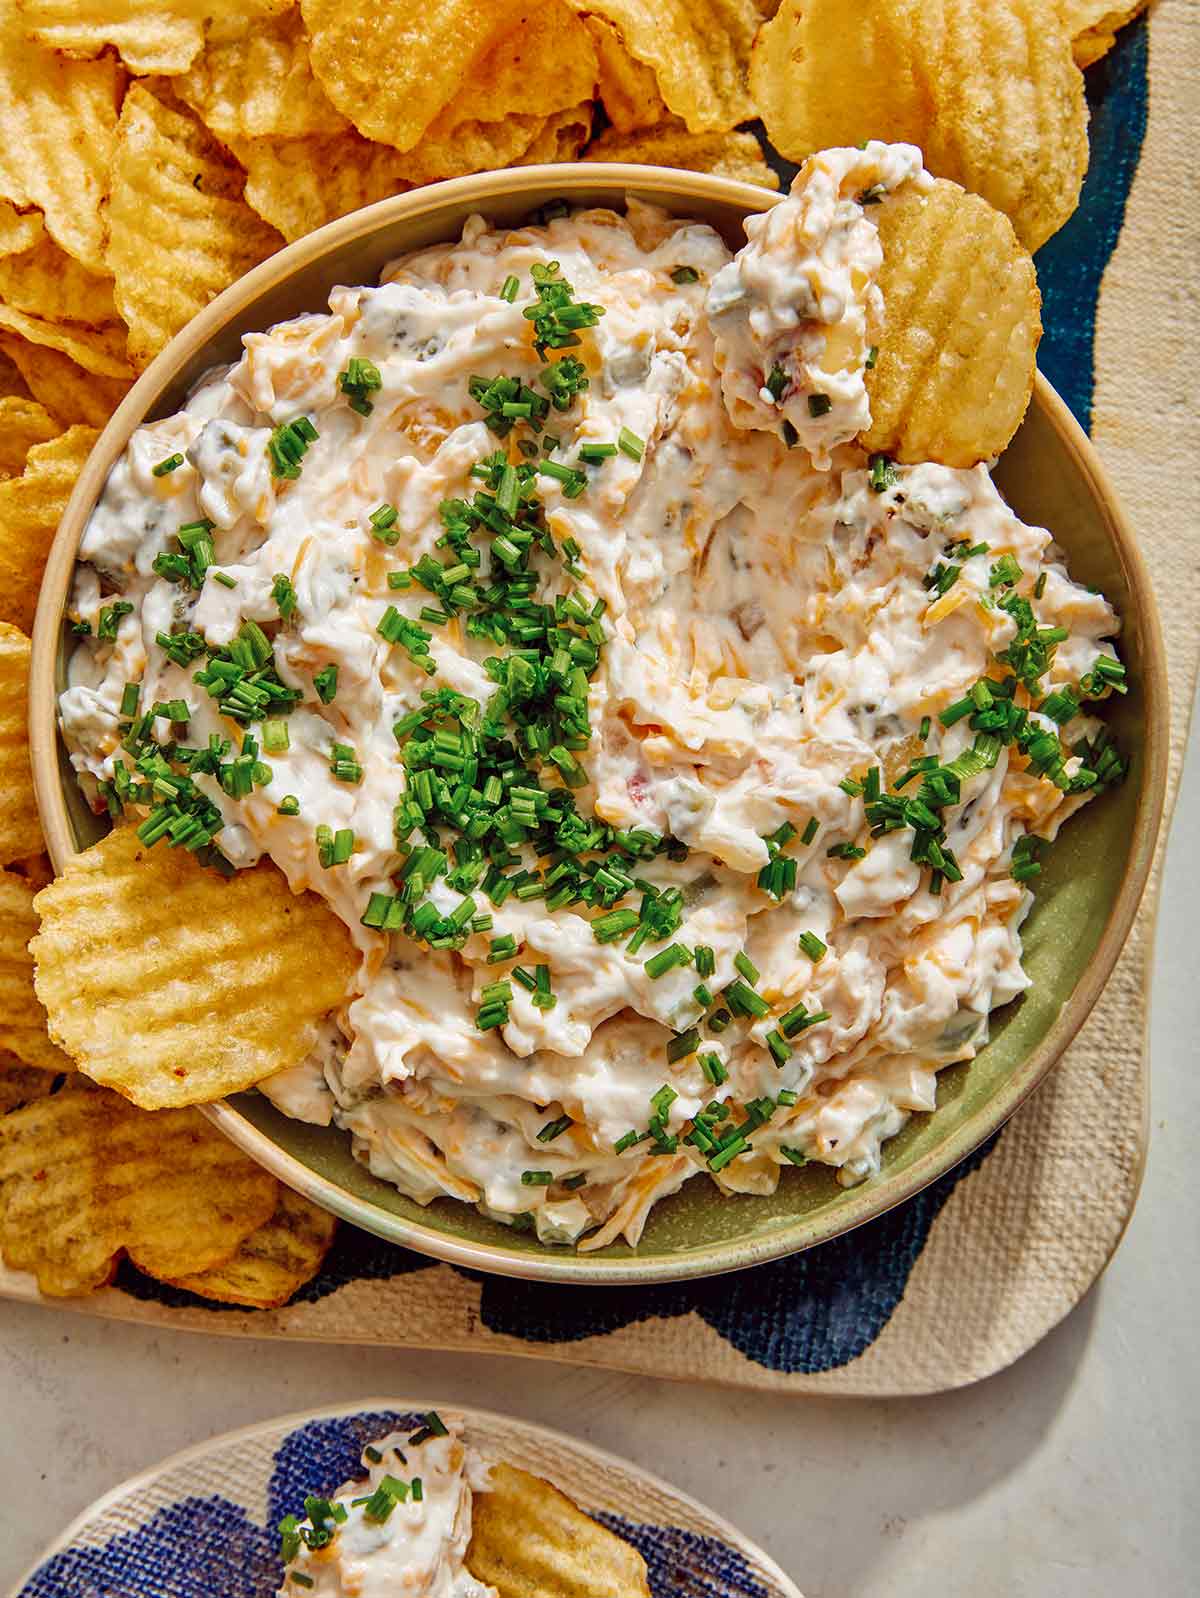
29,161,1170,1286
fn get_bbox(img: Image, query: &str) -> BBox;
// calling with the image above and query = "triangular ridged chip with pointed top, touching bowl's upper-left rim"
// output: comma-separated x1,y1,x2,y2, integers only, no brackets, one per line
107,83,281,368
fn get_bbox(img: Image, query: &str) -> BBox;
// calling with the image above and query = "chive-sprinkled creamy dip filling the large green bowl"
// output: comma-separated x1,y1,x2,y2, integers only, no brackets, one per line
59,144,1125,1248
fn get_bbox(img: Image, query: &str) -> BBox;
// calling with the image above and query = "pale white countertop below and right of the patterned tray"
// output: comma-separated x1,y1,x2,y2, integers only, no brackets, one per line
0,690,1200,1598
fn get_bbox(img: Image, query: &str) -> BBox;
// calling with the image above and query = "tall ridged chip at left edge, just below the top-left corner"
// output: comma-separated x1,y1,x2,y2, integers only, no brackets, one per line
0,17,125,272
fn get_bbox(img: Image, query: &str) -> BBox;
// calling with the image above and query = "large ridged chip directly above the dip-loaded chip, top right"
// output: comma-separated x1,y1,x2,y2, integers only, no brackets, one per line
751,0,1088,249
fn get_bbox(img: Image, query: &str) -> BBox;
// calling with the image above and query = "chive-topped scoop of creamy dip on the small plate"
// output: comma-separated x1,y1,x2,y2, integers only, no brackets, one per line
278,1414,495,1598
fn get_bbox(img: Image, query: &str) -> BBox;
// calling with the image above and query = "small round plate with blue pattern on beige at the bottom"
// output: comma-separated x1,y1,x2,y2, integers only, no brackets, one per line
10,1398,802,1598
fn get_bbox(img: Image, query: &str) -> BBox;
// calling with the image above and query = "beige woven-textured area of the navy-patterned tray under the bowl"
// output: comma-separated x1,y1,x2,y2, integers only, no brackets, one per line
0,0,1200,1395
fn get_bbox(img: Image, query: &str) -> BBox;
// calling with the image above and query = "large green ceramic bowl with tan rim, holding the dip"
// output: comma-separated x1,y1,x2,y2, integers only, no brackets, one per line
30,165,1166,1285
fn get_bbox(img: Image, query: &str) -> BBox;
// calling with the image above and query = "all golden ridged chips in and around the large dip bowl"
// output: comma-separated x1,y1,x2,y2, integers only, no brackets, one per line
0,0,1146,1306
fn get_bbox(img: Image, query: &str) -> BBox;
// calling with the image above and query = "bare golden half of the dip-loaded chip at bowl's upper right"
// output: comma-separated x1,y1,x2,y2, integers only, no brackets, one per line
863,177,1042,467
